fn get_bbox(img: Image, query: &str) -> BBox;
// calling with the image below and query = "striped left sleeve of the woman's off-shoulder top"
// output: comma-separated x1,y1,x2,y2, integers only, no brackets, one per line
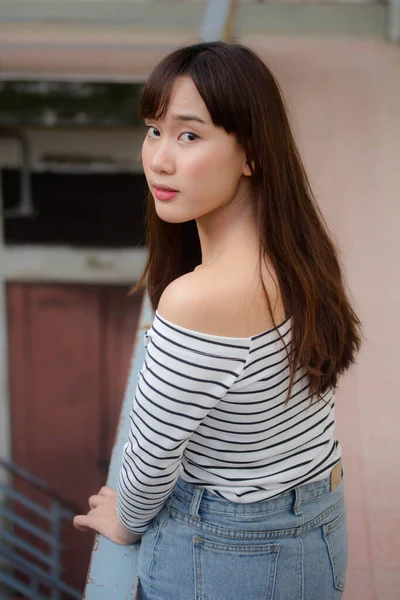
117,313,249,534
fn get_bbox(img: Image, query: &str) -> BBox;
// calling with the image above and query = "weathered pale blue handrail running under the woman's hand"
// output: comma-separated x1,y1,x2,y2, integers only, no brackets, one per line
83,294,153,600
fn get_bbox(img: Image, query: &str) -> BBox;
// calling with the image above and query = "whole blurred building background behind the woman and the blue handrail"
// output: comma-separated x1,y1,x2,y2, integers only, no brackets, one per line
0,0,400,600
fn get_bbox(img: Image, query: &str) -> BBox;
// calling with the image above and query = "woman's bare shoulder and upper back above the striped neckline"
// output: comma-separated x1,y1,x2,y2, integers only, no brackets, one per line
157,268,283,337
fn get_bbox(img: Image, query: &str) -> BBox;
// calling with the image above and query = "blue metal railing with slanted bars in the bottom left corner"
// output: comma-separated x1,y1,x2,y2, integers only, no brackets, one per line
0,458,82,600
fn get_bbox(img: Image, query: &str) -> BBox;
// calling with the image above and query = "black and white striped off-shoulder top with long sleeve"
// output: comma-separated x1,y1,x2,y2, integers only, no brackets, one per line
117,311,341,534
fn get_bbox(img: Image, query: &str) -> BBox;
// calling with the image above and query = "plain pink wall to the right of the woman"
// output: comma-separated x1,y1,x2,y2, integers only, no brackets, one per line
250,38,400,600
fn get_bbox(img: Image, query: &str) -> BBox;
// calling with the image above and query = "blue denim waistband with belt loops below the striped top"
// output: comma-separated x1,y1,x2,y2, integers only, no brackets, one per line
174,459,343,518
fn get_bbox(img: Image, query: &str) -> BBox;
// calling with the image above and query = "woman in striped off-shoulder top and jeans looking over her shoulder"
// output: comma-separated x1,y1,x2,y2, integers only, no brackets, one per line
74,42,361,600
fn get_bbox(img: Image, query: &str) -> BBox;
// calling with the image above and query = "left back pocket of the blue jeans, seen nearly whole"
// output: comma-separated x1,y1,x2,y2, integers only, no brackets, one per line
193,536,280,600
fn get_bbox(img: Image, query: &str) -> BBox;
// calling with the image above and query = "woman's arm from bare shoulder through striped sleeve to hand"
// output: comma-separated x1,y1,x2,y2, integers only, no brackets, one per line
74,278,248,544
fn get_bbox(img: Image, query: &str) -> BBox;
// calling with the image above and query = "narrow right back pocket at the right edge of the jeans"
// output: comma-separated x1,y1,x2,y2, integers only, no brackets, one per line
322,510,348,591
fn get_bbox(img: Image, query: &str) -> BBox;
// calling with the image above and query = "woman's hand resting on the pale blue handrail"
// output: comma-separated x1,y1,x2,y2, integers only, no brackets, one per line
73,486,142,545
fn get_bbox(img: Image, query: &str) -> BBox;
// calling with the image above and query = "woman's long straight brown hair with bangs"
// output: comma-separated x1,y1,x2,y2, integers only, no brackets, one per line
130,41,361,403
